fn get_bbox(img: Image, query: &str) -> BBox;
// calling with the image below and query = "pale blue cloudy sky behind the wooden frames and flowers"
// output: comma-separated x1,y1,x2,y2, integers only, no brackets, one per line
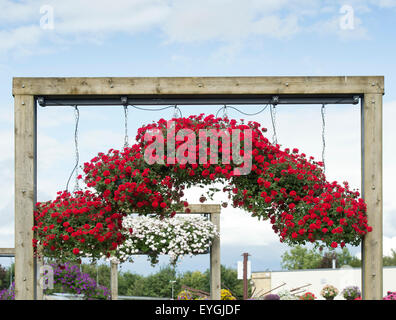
0,0,396,274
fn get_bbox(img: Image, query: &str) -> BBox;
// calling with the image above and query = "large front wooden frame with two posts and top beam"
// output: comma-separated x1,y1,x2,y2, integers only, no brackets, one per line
12,76,384,299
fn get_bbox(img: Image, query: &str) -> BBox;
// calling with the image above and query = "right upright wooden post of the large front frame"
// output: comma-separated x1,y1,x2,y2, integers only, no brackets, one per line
362,94,383,300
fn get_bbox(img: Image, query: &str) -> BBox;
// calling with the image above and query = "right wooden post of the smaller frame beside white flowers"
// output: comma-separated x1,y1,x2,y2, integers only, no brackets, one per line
210,212,221,300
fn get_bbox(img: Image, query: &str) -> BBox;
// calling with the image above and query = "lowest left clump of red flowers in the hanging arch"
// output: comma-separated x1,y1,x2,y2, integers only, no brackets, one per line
33,190,124,261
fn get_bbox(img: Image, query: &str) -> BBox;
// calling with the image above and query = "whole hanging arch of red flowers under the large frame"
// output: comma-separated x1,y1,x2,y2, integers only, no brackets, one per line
33,114,372,257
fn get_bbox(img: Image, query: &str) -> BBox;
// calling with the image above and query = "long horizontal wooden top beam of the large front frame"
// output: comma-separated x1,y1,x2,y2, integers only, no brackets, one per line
13,76,384,96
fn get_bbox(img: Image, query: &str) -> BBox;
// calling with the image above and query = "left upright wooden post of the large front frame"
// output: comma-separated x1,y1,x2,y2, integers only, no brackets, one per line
14,95,37,300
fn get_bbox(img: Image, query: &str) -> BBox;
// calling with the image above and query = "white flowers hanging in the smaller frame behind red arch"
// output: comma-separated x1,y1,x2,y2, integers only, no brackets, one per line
115,216,219,265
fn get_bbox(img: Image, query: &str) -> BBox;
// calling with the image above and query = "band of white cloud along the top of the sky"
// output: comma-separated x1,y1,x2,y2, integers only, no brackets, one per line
0,0,395,54
